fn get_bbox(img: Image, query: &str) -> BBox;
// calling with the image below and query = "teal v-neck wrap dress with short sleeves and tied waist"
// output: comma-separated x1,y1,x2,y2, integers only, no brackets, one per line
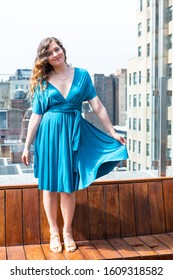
32,68,128,193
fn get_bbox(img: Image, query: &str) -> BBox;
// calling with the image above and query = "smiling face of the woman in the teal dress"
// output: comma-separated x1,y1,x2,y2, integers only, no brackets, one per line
47,41,65,67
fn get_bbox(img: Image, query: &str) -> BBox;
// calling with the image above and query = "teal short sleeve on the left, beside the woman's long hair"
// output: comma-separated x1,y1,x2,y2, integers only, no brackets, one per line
32,89,48,115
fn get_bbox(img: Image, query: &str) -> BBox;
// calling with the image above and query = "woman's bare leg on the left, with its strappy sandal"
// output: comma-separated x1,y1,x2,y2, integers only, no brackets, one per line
43,191,62,253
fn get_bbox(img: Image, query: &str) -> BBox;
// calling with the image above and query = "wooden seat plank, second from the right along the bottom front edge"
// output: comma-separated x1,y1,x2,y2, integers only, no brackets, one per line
124,237,158,260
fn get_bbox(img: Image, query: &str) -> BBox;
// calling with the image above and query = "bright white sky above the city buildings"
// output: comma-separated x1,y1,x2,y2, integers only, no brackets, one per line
0,0,138,75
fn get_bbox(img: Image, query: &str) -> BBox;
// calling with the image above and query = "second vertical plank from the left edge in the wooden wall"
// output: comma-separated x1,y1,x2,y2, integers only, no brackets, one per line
6,190,23,246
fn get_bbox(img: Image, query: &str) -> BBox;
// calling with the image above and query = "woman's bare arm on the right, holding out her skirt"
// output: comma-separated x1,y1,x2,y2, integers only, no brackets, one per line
88,96,126,144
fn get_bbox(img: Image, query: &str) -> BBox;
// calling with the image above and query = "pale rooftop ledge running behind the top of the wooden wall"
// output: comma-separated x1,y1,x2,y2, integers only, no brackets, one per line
0,170,173,189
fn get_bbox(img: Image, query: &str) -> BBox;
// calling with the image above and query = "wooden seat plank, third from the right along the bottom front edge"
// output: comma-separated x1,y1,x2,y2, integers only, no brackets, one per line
108,238,141,260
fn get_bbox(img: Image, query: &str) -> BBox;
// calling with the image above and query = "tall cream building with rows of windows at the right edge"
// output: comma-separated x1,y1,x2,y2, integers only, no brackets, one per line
127,0,173,174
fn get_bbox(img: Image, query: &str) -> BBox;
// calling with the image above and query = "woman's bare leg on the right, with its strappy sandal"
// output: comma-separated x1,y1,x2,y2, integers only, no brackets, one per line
61,192,76,252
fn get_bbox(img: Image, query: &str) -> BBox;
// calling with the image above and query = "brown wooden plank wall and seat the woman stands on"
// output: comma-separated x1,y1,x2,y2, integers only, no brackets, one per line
0,175,173,260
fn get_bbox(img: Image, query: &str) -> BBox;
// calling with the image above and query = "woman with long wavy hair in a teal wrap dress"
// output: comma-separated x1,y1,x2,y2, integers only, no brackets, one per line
22,37,128,253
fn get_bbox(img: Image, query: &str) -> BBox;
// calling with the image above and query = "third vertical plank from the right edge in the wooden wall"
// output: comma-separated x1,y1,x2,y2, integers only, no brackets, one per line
134,183,151,235
